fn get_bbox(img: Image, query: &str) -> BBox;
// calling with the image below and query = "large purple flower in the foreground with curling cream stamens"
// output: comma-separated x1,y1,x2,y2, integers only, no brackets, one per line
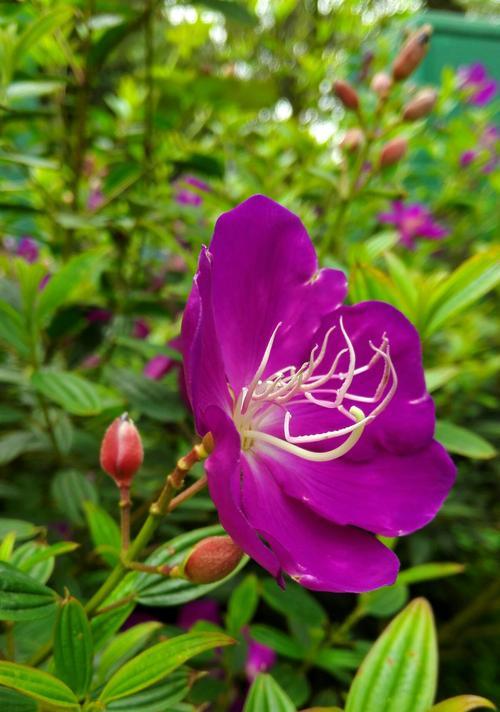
182,196,455,592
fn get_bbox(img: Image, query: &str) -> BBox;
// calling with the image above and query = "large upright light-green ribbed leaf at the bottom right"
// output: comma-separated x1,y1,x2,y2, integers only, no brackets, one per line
345,598,437,712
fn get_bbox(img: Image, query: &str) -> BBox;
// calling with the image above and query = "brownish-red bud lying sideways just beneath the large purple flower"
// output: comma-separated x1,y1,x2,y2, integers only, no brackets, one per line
183,536,243,583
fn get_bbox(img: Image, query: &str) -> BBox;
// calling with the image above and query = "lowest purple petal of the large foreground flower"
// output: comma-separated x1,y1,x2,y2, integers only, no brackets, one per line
241,456,399,593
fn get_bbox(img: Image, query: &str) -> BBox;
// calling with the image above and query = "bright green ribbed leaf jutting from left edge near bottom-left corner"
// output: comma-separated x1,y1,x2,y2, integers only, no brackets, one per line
0,661,79,710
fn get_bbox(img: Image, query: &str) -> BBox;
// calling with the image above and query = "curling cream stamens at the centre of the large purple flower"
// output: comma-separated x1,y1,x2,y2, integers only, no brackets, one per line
233,317,398,462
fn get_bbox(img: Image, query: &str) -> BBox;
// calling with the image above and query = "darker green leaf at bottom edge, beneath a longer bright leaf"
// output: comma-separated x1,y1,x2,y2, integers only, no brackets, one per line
106,668,190,712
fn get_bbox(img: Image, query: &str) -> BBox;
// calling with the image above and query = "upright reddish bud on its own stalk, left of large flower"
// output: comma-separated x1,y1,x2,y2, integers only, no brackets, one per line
100,413,144,487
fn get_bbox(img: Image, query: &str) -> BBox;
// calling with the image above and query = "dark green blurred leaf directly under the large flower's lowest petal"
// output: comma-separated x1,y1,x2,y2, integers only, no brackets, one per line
262,579,327,626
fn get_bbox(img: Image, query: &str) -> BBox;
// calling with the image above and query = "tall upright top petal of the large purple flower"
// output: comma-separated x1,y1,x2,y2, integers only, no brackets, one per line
210,195,346,393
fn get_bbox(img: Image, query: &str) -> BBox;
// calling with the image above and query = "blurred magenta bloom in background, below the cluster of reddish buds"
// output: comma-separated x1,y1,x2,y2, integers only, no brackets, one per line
378,200,449,250
